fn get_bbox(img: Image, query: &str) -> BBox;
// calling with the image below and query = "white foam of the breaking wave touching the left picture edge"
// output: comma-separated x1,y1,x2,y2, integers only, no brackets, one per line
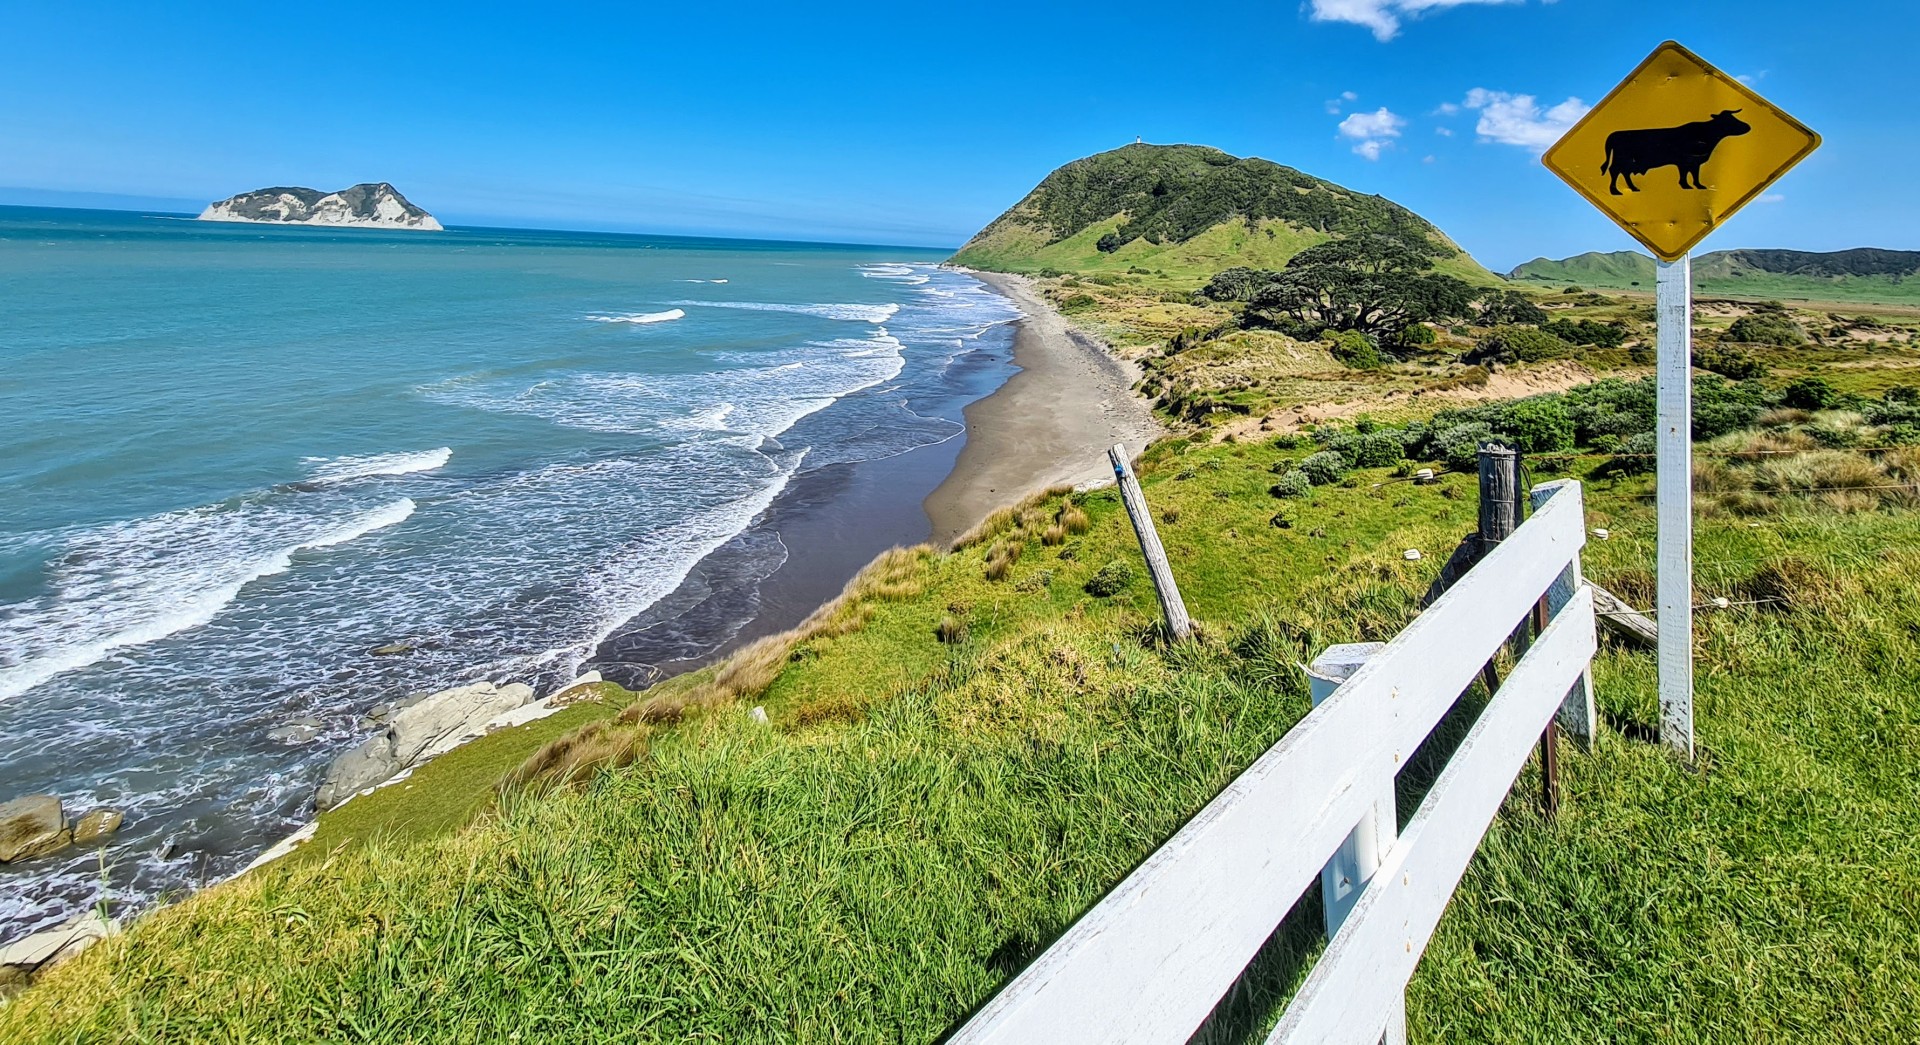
0,498,415,699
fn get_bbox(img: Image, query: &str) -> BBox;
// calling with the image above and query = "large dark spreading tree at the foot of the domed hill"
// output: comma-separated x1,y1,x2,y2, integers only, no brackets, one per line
1246,234,1473,342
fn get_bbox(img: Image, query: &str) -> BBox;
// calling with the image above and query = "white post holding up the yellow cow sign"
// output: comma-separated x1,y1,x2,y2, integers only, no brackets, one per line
1655,255,1693,761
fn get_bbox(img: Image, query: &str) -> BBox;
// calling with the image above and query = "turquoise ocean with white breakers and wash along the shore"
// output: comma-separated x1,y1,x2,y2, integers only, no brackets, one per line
0,207,1020,941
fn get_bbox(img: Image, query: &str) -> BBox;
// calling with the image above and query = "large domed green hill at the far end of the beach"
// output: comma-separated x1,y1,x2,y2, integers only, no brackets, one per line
952,144,1500,284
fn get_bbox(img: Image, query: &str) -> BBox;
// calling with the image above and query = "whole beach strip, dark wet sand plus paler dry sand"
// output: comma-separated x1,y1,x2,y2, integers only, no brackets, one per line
588,273,1162,688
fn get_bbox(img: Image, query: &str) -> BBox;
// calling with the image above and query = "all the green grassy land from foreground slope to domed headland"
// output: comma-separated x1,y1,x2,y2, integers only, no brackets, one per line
11,146,1920,1043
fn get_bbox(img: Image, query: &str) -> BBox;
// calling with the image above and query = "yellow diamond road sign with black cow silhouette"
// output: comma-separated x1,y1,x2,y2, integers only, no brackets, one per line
1542,40,1820,261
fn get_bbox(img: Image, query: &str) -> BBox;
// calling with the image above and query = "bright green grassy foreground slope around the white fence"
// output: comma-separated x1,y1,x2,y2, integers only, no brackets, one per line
11,428,1920,1043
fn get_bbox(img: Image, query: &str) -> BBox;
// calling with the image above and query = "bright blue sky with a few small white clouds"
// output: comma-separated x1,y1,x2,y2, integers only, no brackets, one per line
0,0,1920,269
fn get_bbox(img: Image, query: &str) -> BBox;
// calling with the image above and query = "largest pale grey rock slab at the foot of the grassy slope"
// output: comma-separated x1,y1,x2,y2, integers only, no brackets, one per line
313,682,534,813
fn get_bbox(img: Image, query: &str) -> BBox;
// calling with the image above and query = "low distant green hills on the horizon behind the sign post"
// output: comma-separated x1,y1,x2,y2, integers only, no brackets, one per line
1507,248,1920,305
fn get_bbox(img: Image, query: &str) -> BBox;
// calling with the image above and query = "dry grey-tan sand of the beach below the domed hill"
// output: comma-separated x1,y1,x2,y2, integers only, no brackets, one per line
925,273,1165,542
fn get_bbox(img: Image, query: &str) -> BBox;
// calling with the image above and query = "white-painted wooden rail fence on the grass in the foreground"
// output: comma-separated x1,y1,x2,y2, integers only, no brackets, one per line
950,482,1594,1045
